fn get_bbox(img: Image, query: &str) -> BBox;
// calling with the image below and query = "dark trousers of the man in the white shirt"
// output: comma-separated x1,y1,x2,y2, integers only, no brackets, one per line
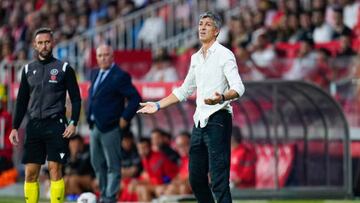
189,110,232,203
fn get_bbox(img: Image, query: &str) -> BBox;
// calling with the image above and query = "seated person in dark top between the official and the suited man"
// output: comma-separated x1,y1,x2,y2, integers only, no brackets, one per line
64,135,96,200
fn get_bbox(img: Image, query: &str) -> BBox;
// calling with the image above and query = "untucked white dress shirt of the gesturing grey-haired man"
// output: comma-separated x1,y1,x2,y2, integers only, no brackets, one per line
173,41,245,128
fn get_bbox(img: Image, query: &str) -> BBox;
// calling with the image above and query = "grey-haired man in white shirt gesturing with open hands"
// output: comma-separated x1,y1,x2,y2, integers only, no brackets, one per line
137,12,245,203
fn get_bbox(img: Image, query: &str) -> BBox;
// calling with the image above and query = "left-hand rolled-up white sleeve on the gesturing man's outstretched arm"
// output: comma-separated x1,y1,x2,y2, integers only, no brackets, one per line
172,60,196,101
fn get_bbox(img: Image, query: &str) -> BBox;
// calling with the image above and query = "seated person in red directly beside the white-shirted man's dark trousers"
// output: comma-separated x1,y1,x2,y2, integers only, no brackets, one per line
159,132,192,195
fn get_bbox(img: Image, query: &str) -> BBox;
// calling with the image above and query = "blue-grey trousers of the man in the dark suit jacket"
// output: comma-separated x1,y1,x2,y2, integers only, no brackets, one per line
90,125,121,203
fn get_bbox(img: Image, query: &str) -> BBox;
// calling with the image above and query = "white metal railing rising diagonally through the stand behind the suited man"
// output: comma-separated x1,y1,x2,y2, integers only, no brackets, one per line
54,0,221,79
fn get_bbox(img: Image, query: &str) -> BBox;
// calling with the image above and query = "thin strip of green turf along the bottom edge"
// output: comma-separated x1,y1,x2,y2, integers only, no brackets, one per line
0,197,360,203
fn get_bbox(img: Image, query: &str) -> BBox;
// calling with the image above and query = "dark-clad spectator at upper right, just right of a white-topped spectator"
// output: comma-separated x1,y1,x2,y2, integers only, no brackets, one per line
332,8,352,39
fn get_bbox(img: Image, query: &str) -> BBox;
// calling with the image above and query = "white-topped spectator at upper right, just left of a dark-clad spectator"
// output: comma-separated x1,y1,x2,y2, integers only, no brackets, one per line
312,10,334,43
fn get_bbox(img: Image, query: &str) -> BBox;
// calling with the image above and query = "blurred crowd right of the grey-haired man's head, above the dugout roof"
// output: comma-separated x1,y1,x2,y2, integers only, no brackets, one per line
218,0,360,88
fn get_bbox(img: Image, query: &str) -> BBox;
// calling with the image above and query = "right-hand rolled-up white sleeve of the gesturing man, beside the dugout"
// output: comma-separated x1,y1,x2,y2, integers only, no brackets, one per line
224,53,245,97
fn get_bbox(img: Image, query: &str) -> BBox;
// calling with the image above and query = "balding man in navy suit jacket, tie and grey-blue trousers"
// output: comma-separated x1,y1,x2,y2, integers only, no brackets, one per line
87,45,141,203
